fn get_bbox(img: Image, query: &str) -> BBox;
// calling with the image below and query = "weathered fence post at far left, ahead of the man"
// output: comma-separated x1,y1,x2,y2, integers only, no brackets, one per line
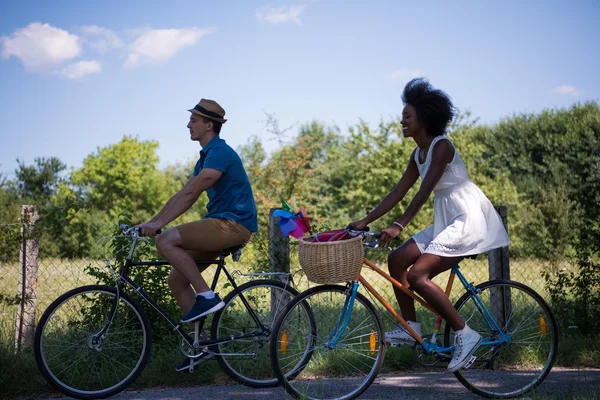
15,205,39,351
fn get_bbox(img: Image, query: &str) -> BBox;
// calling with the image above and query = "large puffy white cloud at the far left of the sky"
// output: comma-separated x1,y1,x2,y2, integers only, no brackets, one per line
0,22,81,72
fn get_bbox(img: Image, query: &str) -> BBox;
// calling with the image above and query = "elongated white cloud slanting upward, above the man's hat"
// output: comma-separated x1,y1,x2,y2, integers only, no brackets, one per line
124,28,215,68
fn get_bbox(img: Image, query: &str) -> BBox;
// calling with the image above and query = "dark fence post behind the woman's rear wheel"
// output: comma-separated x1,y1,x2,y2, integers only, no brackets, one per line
488,206,512,328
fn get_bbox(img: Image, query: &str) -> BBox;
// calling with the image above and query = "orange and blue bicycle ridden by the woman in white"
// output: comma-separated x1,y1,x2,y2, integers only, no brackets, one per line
271,232,558,400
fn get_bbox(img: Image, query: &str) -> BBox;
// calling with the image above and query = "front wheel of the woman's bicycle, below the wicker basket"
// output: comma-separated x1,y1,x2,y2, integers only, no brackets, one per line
271,285,385,400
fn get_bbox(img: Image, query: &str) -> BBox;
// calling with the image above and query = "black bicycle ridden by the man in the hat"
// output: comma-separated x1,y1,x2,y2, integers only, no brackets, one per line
34,225,314,399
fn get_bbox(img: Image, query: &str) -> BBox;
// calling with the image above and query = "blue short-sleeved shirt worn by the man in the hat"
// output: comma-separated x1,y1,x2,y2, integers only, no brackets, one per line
194,136,258,232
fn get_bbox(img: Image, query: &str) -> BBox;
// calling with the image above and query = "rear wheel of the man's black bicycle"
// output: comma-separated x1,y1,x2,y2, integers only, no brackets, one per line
212,279,310,388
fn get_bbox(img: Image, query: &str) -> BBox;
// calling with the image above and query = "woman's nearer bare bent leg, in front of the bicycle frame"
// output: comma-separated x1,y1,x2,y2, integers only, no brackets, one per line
407,253,465,331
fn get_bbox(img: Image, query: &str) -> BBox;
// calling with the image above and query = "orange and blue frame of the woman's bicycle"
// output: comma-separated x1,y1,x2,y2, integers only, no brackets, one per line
328,258,511,357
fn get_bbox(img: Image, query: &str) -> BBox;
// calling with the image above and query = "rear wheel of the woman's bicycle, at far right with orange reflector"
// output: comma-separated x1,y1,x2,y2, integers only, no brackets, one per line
445,280,558,398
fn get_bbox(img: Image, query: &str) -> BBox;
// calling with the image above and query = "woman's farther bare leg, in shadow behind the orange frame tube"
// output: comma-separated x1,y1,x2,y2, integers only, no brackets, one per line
388,239,421,322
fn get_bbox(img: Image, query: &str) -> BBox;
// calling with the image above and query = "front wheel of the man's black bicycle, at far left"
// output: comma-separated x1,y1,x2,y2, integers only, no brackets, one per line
34,285,151,399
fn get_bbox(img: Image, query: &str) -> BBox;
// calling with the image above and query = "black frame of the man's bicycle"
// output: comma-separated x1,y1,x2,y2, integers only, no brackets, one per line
94,236,269,358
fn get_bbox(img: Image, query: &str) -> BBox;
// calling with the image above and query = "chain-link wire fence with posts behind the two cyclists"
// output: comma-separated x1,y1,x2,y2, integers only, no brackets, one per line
0,206,571,349
